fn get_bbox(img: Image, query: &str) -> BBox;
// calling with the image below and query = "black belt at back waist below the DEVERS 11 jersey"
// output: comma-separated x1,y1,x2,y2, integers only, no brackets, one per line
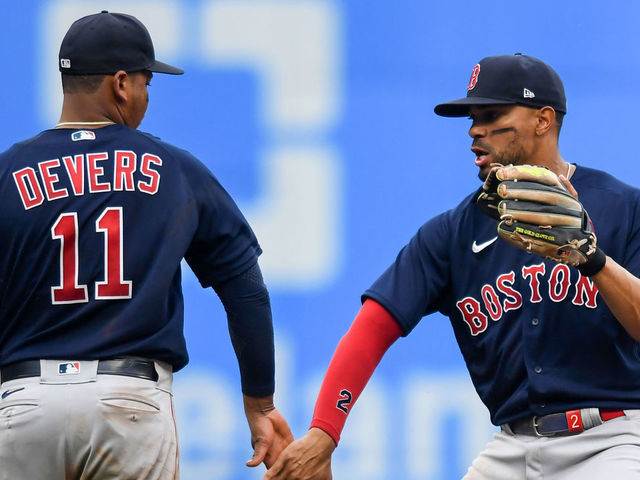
0,358,158,383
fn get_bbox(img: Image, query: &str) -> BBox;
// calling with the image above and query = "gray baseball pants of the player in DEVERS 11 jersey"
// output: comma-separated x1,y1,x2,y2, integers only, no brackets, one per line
0,360,179,480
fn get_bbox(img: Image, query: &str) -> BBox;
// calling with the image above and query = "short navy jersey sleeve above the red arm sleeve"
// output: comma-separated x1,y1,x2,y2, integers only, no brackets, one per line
362,211,453,336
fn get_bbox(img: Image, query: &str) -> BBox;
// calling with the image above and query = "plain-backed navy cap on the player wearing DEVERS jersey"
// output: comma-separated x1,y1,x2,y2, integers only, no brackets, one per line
58,10,184,75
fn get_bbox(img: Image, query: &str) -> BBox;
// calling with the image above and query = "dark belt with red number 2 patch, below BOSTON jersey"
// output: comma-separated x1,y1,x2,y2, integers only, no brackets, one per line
508,408,625,437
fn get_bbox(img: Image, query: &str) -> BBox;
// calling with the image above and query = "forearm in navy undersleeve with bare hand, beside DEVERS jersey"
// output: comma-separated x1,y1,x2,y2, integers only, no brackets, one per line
214,263,293,468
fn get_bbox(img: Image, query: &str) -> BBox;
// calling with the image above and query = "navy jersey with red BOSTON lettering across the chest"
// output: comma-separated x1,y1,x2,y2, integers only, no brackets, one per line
363,167,640,425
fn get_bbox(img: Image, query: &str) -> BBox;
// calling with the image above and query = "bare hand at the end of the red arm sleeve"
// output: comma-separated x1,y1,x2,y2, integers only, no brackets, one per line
262,428,336,480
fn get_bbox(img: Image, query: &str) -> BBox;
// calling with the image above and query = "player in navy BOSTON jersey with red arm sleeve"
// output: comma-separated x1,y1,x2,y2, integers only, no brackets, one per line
264,54,640,480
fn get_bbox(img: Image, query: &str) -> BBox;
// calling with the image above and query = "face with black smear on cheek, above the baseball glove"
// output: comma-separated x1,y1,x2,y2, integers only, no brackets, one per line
469,105,537,180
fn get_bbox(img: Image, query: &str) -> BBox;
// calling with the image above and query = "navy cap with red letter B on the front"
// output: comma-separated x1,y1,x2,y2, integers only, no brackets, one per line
434,53,567,117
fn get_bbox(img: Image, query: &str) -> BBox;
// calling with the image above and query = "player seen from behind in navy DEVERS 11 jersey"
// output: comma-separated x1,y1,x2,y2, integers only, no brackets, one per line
0,11,293,480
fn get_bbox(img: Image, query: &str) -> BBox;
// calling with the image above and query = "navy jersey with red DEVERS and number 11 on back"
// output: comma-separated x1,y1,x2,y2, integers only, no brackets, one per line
0,125,261,370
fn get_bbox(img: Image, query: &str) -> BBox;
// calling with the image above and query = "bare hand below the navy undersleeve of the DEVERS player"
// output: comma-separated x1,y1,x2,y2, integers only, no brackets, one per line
244,395,293,468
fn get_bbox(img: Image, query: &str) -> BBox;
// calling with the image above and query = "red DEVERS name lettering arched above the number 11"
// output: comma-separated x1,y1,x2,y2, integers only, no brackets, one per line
13,150,162,210
